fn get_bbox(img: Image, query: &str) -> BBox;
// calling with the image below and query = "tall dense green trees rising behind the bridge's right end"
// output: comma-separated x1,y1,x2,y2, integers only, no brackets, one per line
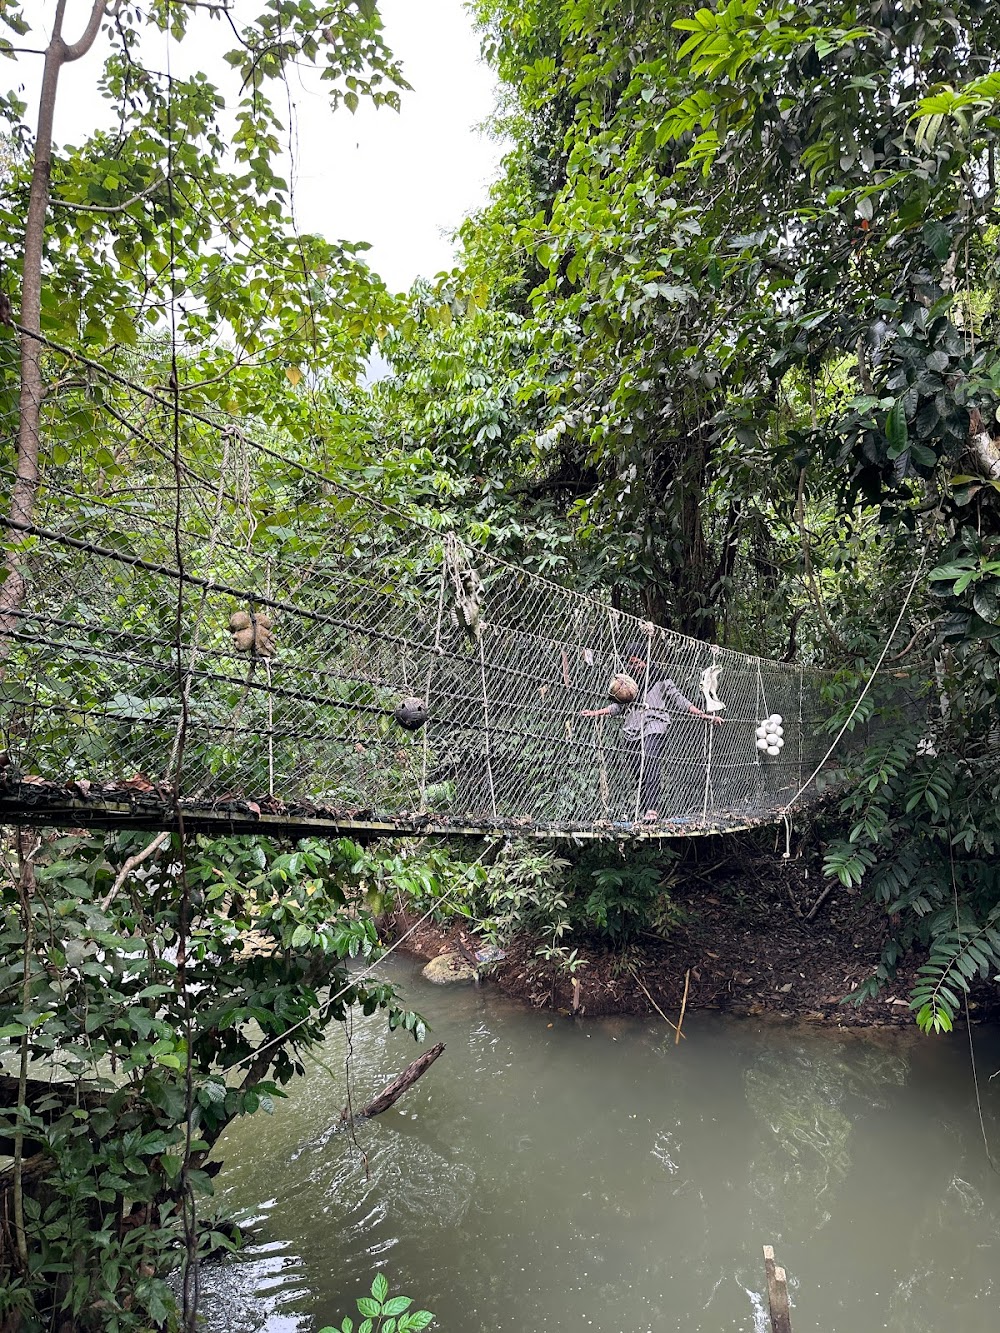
442,0,1000,1025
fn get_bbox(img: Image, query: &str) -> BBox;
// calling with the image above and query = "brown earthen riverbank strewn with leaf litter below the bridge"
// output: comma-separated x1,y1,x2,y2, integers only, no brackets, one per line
391,849,996,1028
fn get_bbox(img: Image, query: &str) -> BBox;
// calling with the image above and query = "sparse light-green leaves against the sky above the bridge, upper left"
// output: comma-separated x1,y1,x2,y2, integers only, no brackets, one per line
0,0,408,415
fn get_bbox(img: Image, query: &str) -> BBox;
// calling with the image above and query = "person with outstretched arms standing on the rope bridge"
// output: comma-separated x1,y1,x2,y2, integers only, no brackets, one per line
580,644,721,822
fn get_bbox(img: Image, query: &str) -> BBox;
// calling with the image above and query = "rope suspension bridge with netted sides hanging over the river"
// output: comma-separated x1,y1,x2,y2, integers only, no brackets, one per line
0,333,858,838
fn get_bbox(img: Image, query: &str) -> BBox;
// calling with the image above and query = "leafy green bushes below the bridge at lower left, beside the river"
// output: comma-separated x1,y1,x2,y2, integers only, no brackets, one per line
0,834,432,1329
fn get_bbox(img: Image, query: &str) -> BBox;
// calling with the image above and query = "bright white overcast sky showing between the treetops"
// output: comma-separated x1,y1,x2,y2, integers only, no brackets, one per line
11,0,503,291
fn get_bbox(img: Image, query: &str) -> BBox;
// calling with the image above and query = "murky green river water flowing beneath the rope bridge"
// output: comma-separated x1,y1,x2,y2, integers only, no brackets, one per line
203,960,1000,1333
